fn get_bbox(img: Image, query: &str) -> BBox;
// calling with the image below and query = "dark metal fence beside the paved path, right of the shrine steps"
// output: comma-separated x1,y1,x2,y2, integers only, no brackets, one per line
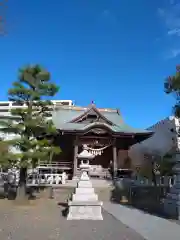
111,176,176,216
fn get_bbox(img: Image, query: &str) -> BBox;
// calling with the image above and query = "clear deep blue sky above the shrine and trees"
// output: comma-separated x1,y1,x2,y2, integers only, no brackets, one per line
0,0,180,128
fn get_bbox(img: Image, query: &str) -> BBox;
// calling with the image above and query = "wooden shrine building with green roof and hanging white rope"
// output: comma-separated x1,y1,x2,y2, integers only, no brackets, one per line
48,104,153,176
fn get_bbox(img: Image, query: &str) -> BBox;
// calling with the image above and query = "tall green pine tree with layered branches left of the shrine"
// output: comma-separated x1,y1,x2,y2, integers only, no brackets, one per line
0,65,60,197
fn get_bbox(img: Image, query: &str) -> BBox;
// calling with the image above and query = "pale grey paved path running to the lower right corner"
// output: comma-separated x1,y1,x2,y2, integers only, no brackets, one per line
103,202,180,240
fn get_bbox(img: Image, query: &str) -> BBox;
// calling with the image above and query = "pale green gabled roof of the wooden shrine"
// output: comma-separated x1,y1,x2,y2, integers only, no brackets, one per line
52,105,152,135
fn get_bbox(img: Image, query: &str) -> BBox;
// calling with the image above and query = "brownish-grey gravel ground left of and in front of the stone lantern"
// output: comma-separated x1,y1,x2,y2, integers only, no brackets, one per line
0,190,144,240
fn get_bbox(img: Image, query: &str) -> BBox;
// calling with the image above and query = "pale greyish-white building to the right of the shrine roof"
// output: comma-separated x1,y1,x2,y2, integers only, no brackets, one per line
128,116,180,166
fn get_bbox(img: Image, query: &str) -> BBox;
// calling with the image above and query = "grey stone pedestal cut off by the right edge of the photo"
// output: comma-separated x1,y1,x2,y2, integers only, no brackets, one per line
164,152,180,220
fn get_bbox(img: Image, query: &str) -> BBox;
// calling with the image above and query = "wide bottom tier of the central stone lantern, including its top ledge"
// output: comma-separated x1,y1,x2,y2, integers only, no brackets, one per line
67,202,103,220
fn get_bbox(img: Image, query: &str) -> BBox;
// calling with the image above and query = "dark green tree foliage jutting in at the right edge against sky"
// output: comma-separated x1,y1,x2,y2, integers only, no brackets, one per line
164,65,180,117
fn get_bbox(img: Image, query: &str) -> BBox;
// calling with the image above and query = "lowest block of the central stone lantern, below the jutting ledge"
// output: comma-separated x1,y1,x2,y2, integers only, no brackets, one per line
67,205,103,220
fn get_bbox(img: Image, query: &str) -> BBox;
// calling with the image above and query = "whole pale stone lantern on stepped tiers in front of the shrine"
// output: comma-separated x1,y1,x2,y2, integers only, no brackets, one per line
67,145,103,220
